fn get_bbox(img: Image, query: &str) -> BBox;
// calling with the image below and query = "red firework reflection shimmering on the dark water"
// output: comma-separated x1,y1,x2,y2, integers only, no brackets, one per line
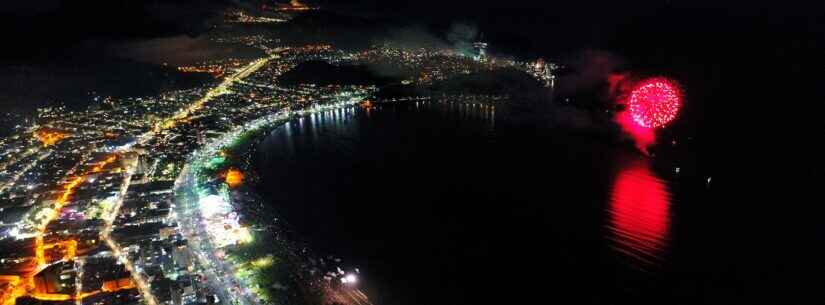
608,161,670,264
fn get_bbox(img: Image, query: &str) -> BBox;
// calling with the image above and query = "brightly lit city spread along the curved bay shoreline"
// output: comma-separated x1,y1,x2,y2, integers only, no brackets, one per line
0,1,557,305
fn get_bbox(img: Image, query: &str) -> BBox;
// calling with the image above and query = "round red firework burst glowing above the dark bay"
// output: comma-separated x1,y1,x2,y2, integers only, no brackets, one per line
628,77,682,128
